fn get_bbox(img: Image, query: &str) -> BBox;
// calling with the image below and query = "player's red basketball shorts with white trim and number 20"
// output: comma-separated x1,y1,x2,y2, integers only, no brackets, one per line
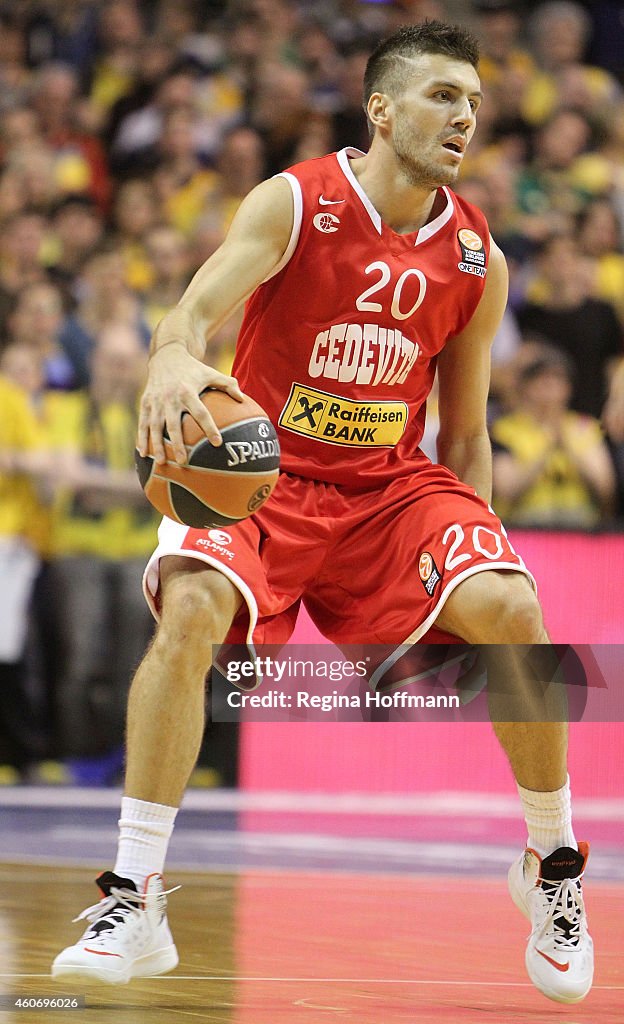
143,458,535,644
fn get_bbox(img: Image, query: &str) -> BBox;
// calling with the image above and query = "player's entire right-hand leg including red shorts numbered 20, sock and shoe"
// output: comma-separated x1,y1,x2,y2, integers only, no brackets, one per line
313,473,591,1001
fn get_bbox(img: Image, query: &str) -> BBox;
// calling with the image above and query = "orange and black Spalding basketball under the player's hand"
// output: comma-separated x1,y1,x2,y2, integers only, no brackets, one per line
134,388,280,529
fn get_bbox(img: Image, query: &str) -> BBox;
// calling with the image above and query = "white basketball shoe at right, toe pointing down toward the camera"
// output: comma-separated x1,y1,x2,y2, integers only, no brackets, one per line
508,843,593,1002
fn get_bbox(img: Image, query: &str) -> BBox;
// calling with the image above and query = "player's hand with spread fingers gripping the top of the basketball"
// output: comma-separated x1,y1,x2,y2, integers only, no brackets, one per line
136,341,243,466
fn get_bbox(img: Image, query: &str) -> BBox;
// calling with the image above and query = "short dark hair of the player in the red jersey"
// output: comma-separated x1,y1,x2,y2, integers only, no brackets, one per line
364,20,479,129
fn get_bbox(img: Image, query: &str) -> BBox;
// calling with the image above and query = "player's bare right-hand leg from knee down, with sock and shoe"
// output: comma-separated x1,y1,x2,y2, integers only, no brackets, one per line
436,571,593,1002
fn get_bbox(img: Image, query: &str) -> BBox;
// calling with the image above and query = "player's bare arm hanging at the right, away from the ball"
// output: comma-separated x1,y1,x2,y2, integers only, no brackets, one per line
438,233,508,502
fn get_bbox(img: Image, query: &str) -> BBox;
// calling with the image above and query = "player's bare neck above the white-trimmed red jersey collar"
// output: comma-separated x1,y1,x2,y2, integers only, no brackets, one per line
349,146,438,234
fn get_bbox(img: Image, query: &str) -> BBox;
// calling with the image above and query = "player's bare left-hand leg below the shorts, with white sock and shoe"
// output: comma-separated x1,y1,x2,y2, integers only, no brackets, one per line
52,556,242,984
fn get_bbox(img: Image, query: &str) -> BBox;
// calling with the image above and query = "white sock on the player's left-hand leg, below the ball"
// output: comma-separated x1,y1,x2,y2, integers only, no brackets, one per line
113,797,177,892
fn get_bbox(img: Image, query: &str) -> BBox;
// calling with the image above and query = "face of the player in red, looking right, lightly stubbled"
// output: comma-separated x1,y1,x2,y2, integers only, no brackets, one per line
391,54,482,188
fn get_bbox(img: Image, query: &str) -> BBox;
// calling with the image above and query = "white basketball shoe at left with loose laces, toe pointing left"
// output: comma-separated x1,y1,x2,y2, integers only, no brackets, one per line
52,871,179,985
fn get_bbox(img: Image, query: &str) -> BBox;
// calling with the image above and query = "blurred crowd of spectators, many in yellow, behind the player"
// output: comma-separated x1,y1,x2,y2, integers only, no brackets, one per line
0,0,624,781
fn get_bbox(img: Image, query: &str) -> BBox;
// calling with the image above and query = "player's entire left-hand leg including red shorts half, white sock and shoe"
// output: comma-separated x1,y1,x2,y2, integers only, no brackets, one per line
52,474,324,983
